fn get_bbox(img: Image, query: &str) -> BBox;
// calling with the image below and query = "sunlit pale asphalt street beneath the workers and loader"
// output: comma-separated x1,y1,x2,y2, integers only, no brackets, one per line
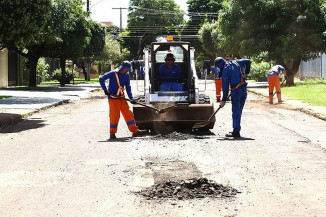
0,81,326,217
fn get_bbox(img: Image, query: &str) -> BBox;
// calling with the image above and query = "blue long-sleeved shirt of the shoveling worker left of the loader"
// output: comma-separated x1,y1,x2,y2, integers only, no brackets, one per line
99,68,134,100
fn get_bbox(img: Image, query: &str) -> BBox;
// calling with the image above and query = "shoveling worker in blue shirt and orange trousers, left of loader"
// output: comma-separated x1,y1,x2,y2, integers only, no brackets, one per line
99,61,144,139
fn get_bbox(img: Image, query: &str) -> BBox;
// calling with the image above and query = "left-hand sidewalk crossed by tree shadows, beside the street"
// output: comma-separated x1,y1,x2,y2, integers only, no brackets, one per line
0,84,101,129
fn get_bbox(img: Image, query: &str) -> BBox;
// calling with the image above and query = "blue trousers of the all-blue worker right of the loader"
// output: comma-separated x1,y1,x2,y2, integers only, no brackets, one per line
231,86,247,132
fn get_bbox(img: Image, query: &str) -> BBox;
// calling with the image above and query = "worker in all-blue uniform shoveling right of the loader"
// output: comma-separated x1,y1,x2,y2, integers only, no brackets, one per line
216,57,251,137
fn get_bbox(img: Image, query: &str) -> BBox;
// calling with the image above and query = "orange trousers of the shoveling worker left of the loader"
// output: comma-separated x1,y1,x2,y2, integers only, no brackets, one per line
109,99,138,134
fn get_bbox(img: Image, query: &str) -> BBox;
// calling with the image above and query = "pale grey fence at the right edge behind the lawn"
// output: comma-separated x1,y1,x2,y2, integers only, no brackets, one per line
296,54,326,79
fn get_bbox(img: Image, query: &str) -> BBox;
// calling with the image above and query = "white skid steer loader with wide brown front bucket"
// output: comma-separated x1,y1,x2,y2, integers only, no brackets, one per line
133,36,215,133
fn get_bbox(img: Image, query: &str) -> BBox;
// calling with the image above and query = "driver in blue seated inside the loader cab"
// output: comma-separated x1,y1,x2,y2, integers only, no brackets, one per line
159,53,183,91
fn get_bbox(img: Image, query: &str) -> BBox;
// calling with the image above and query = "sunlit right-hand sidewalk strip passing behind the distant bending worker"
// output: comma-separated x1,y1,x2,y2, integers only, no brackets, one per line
248,82,326,121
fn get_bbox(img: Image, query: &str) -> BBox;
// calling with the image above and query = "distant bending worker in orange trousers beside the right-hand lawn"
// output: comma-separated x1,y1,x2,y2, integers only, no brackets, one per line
267,65,286,104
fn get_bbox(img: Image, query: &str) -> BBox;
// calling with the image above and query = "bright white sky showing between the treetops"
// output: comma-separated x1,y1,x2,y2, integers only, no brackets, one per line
83,0,187,28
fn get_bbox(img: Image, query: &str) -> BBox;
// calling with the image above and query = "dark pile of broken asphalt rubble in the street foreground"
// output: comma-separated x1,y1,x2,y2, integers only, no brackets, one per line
139,178,240,200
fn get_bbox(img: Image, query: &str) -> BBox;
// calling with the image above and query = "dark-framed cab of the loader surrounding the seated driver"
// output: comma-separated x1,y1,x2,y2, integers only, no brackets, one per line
150,41,191,95
